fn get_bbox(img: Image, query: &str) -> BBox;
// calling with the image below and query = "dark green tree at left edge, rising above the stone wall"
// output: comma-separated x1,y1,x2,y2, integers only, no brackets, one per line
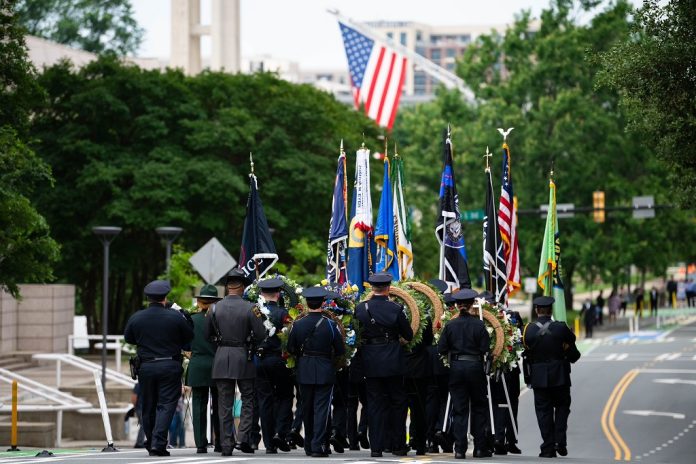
0,0,58,297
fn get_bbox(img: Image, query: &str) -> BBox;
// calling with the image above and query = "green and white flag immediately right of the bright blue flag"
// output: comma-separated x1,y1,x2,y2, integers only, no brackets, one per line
392,153,413,280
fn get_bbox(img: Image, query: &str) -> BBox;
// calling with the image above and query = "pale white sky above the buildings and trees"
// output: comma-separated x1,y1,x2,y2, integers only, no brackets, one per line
131,0,549,69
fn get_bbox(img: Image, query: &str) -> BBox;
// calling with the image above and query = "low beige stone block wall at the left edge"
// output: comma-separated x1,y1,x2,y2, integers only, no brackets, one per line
0,284,75,353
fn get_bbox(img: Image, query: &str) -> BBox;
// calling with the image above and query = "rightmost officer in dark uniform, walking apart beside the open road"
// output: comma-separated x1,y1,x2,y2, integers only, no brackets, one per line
523,296,579,458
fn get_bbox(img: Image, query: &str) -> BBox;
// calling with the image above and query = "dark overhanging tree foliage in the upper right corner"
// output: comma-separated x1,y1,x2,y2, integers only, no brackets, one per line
598,0,696,207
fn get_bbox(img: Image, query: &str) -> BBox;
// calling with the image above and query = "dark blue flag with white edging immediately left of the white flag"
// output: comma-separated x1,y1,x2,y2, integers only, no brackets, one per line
326,141,348,284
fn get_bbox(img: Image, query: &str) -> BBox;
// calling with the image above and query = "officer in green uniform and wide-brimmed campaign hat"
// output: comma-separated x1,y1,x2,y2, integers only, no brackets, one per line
186,285,222,453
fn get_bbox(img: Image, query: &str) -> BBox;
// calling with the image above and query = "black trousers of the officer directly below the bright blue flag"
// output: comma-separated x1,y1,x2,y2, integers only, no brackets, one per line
365,376,407,451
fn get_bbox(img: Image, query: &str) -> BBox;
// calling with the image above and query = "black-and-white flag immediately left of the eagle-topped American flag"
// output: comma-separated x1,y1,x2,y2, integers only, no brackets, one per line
483,168,507,304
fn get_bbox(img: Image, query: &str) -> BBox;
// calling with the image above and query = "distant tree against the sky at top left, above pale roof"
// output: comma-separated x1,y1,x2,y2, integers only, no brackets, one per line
15,0,144,56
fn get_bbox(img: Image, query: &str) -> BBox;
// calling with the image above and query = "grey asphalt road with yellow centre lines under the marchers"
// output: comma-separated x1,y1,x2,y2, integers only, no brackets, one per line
0,323,696,464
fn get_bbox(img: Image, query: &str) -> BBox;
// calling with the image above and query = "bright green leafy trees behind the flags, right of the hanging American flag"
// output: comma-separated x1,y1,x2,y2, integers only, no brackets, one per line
395,0,693,307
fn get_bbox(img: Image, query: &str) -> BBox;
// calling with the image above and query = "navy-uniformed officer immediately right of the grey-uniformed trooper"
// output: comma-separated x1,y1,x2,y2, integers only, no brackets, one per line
255,279,293,454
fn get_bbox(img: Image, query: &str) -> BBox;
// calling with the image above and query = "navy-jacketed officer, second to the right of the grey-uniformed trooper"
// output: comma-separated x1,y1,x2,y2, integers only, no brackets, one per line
287,287,344,457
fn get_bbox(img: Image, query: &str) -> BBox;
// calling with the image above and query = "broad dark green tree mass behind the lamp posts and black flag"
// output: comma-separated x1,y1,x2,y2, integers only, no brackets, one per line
33,57,377,331
